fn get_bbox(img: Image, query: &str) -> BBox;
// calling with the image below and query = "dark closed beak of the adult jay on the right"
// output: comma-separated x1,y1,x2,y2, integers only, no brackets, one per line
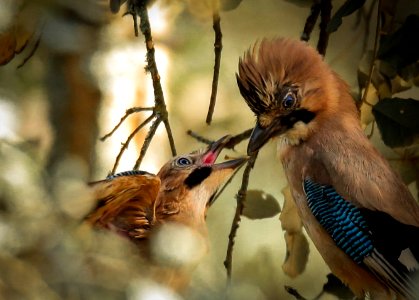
247,122,287,155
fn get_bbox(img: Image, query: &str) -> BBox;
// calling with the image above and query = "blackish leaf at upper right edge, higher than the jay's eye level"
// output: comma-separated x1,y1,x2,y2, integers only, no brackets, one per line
377,15,419,73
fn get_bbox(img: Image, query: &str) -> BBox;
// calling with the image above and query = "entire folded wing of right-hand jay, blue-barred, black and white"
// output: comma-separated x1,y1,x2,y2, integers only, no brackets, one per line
303,179,419,299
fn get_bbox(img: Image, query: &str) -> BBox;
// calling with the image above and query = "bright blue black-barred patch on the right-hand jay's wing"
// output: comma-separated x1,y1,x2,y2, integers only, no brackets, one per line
304,179,374,264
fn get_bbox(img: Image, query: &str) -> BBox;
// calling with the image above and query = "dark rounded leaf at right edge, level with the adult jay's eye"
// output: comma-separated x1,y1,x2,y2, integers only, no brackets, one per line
372,98,419,147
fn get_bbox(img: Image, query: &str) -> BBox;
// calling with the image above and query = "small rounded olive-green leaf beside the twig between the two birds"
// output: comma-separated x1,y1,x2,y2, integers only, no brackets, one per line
243,190,281,220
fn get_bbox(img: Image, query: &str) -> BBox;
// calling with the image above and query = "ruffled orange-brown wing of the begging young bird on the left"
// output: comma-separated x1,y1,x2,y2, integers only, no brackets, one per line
86,171,161,239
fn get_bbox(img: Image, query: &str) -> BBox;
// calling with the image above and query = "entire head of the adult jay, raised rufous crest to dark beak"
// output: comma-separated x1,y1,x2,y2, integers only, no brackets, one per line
236,38,356,153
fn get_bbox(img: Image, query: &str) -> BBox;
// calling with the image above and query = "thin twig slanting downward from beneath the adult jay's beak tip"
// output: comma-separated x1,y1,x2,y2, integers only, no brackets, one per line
224,152,258,280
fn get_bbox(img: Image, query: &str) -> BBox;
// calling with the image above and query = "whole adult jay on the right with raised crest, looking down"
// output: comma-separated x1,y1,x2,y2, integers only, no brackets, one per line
237,38,419,299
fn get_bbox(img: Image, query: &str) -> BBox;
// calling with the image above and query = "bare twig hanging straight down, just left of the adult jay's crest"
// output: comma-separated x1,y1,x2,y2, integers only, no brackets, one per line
206,8,223,125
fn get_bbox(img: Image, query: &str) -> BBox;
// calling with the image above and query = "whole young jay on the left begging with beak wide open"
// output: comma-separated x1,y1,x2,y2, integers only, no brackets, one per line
86,136,246,290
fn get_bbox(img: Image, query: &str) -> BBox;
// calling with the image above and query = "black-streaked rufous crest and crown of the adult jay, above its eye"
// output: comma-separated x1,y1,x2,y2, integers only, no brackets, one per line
236,38,347,115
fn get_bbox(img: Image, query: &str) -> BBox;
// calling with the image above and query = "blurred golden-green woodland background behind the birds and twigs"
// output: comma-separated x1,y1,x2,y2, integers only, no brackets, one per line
0,0,419,299
